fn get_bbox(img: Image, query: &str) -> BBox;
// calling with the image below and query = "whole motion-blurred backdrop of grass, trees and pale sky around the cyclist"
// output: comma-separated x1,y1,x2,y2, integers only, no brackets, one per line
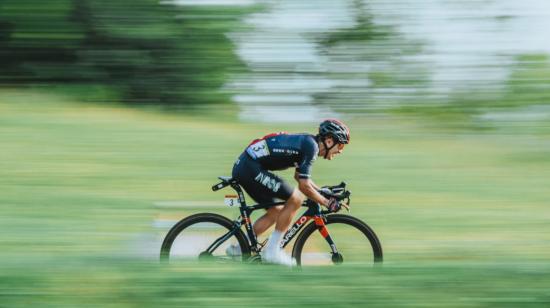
0,0,550,307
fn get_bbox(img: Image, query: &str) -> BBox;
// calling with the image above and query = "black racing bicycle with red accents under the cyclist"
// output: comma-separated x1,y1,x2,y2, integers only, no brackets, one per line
160,176,383,266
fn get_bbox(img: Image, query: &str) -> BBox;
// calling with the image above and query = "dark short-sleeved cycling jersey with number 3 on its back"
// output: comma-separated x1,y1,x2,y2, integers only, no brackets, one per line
245,133,319,179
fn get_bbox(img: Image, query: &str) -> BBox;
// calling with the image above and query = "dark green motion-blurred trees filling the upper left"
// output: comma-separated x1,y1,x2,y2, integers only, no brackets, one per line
0,0,247,105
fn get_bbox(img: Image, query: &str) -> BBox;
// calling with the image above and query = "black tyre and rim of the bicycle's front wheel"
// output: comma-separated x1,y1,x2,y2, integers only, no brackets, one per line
292,214,383,266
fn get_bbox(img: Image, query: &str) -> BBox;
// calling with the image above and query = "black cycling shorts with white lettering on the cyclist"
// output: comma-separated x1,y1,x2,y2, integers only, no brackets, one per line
232,152,294,204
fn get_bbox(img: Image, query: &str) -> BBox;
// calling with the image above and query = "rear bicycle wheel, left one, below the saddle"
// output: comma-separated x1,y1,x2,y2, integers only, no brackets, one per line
160,213,250,262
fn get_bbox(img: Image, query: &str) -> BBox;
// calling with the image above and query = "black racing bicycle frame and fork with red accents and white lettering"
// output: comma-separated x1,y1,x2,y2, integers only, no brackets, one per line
207,184,338,254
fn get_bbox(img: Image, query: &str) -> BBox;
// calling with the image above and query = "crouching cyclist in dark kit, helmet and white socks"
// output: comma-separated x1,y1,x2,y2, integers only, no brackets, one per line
228,119,350,266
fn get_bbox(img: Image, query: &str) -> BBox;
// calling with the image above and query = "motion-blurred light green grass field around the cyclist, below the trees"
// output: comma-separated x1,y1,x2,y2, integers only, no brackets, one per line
0,89,550,307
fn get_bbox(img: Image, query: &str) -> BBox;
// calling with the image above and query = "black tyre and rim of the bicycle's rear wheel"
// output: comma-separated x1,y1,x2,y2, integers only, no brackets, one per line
160,213,250,262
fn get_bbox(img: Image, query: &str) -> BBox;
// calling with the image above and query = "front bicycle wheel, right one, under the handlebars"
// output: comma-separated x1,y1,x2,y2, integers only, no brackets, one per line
292,214,383,266
